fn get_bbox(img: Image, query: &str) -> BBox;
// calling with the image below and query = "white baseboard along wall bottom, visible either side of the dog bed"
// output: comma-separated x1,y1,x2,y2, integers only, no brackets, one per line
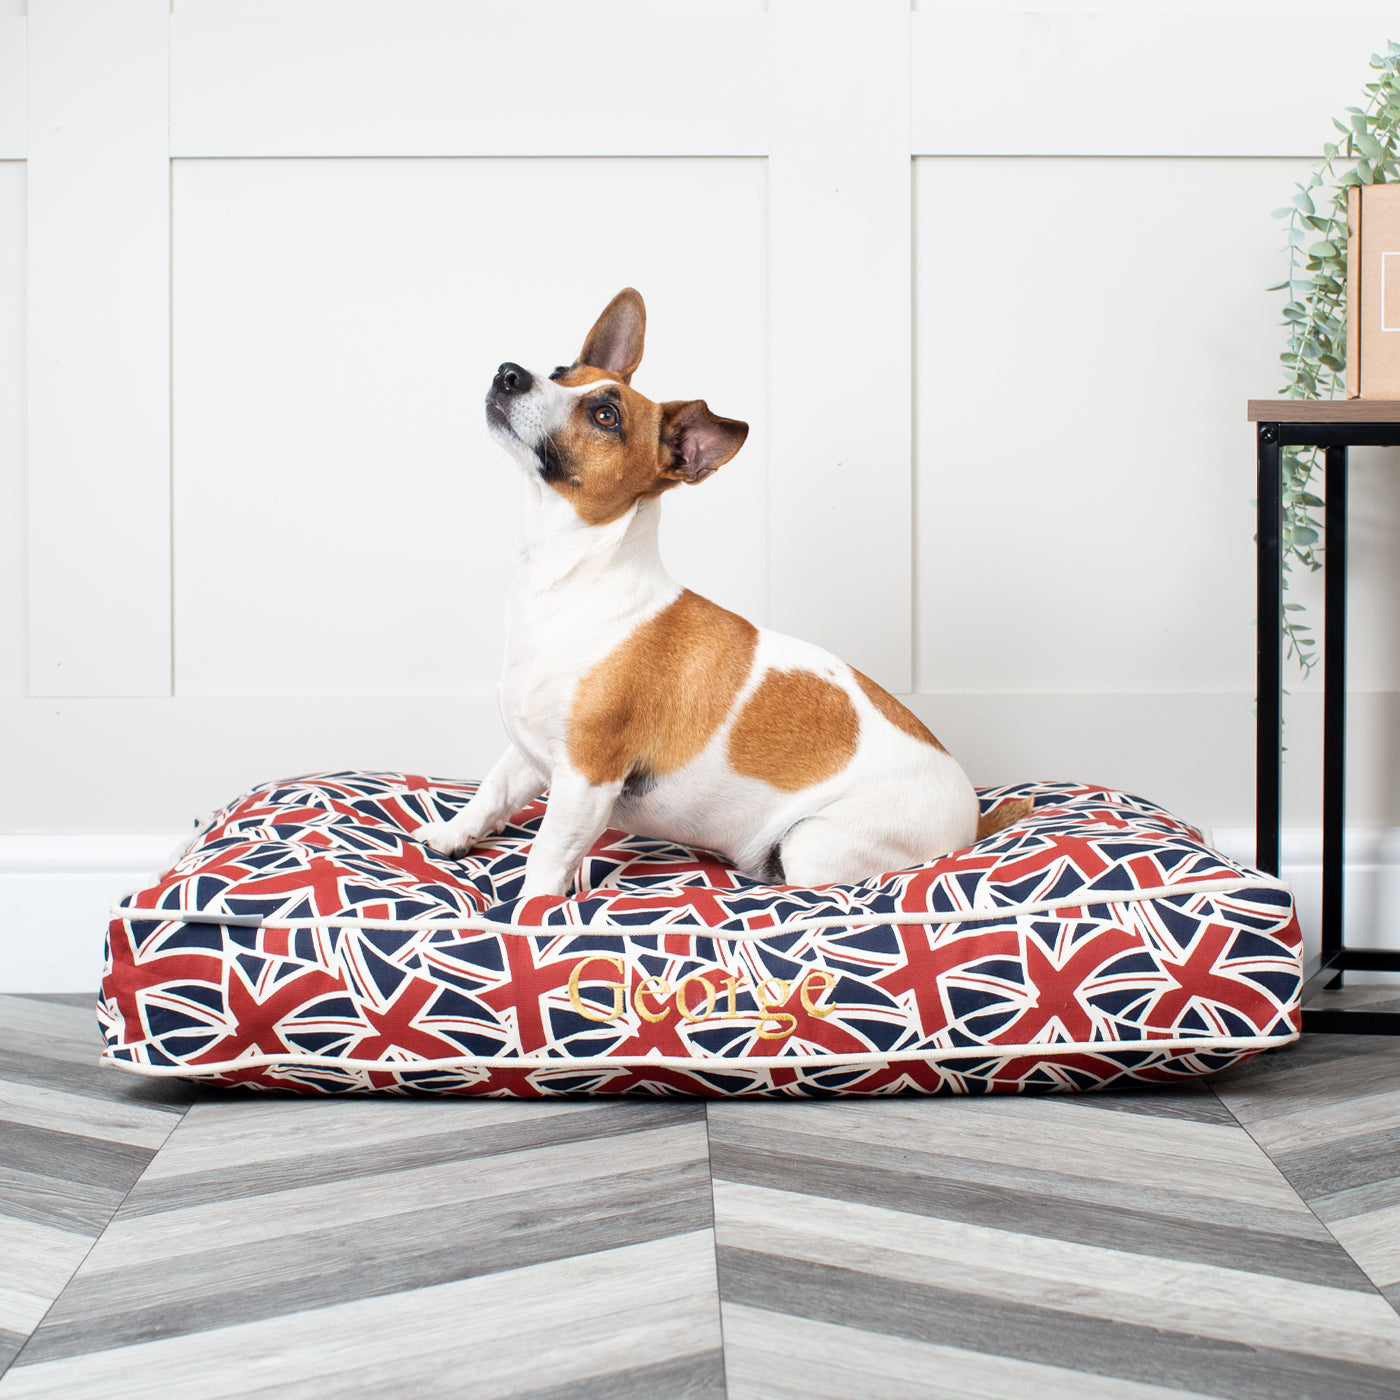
0,827,1400,993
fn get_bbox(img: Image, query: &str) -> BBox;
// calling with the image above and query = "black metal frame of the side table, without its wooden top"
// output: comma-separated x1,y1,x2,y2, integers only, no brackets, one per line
1254,420,1400,1035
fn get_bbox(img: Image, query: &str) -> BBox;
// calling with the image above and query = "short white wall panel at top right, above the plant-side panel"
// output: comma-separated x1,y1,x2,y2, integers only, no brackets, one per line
910,6,1394,156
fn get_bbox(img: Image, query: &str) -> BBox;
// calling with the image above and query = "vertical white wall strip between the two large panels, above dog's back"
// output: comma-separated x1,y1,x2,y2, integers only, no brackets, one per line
769,0,913,692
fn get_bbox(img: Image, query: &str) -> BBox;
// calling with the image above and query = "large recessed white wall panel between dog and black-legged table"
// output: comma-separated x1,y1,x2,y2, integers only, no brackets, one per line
914,157,1306,693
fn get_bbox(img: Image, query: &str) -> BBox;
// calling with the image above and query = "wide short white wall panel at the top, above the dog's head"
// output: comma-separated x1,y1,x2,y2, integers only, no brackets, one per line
171,10,769,157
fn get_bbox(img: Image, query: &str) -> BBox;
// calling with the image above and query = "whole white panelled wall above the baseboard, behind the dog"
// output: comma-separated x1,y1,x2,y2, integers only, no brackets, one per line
0,0,1400,873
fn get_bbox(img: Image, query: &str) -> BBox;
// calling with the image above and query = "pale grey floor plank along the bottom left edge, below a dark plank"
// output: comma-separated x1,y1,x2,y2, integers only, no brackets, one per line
0,1229,722,1400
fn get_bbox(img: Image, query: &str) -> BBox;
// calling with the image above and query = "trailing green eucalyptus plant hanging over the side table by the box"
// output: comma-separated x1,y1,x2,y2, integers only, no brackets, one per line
1268,39,1400,675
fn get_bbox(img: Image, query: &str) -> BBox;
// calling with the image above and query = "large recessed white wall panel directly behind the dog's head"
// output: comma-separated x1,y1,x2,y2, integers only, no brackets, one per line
174,158,769,696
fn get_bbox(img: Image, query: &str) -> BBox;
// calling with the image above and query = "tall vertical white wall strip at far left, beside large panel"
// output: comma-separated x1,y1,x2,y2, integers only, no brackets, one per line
27,0,171,696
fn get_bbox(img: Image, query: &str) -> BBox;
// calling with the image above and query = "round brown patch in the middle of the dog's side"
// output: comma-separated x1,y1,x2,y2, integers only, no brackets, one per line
729,671,861,792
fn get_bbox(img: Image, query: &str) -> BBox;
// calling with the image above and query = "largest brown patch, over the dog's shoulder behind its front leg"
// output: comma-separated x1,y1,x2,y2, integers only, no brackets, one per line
568,589,759,783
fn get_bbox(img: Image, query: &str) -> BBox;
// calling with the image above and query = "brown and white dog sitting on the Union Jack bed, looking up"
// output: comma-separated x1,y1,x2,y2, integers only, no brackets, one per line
414,287,1021,897
